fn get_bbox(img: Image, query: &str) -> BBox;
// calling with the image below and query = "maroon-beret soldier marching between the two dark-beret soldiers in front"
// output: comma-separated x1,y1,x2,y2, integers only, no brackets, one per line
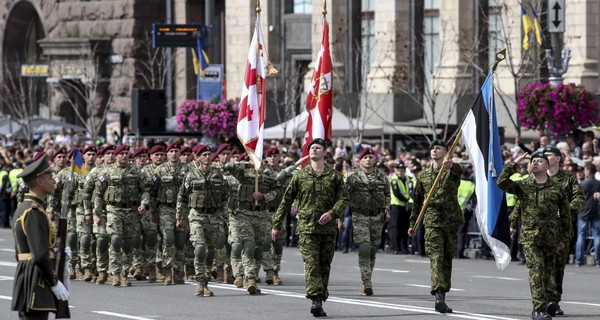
346,148,390,296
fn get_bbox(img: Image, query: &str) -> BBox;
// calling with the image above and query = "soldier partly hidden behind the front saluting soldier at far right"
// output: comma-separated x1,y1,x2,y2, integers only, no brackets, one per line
543,146,585,317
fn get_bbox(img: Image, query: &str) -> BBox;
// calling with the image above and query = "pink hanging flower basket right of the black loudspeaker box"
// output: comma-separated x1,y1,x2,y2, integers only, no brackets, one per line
176,100,238,137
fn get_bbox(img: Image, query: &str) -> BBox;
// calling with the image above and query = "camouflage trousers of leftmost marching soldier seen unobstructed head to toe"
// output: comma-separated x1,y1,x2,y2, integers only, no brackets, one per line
106,206,139,277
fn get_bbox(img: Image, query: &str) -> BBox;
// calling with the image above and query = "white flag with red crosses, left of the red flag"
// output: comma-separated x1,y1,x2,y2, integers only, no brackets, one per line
237,15,277,170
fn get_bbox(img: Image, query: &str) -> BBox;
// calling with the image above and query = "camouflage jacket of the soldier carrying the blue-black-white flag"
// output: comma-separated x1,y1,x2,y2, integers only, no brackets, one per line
410,163,465,228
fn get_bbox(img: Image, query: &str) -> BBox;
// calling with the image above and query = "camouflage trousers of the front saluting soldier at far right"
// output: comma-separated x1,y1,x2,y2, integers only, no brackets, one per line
523,244,564,311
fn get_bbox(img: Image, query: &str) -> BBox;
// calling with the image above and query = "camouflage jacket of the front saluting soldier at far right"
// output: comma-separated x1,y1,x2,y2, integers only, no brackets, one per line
498,162,571,246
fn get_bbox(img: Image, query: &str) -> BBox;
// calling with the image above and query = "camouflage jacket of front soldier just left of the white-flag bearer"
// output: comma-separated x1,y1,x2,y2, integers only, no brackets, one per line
175,166,229,220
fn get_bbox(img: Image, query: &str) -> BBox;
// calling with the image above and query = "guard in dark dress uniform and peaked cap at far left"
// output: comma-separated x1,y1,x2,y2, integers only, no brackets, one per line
11,155,69,319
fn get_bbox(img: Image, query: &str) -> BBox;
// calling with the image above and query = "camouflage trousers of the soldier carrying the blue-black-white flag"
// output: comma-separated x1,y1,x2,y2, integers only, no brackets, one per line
425,224,458,295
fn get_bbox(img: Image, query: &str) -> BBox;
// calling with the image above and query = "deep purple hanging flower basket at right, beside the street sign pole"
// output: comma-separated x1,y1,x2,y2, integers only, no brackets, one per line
517,82,598,136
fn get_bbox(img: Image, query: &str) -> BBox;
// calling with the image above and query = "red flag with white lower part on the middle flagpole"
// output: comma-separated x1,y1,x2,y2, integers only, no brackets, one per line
302,17,333,157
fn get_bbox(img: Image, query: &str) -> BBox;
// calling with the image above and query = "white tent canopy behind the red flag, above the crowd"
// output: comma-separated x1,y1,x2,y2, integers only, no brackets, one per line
264,108,383,139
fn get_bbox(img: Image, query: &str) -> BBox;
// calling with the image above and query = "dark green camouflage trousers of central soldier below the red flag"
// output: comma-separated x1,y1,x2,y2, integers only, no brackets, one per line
299,234,335,301
